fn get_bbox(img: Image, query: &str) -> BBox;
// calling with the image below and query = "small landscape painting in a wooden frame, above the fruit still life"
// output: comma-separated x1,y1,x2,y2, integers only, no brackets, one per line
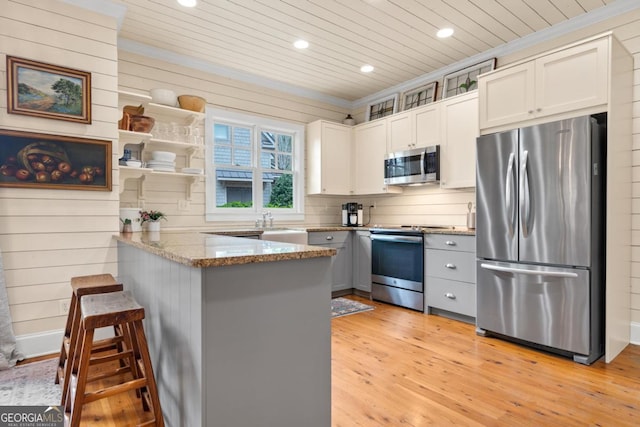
7,55,91,124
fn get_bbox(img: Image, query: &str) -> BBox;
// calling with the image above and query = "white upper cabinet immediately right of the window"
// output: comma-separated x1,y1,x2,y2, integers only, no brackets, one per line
307,120,352,195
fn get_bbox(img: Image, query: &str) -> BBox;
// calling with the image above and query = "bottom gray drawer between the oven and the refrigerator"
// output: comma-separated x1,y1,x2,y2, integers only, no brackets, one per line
425,277,476,317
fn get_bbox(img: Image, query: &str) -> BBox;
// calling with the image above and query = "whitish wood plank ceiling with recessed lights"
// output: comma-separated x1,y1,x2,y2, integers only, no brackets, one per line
104,0,620,101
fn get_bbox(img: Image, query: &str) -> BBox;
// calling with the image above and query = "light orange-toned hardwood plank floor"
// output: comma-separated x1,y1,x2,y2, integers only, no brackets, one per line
23,296,640,427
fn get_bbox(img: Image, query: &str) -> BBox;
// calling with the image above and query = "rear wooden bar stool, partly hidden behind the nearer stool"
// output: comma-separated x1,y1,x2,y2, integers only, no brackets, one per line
55,274,125,394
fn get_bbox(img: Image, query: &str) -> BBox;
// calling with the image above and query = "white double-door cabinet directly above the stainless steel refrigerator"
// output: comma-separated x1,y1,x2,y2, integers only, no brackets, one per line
478,38,609,133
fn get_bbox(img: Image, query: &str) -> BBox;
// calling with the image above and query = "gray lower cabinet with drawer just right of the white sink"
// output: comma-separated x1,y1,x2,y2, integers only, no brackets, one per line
309,231,353,291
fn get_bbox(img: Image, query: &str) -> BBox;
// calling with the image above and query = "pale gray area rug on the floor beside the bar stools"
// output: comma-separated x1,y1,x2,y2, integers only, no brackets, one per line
0,358,62,406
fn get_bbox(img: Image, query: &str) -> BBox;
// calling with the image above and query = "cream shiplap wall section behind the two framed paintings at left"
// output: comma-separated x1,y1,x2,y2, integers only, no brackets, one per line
0,0,119,355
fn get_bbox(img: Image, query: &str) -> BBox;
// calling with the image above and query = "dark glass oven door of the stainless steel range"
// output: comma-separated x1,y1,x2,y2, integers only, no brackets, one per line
371,234,424,292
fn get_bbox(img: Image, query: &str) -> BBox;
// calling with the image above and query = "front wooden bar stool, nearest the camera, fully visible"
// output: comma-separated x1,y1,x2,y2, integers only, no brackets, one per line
62,292,164,427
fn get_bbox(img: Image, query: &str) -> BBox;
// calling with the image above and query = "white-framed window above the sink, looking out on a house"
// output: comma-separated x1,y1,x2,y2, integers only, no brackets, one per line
205,109,304,221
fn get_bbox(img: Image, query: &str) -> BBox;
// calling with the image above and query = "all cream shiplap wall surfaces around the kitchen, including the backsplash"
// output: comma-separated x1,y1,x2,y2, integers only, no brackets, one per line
0,0,640,351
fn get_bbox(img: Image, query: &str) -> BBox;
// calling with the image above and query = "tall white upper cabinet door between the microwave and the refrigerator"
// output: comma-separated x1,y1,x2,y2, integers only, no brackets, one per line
440,91,479,188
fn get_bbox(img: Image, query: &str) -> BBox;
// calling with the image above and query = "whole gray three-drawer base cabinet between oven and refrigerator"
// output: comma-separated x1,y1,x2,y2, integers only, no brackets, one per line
424,234,476,322
